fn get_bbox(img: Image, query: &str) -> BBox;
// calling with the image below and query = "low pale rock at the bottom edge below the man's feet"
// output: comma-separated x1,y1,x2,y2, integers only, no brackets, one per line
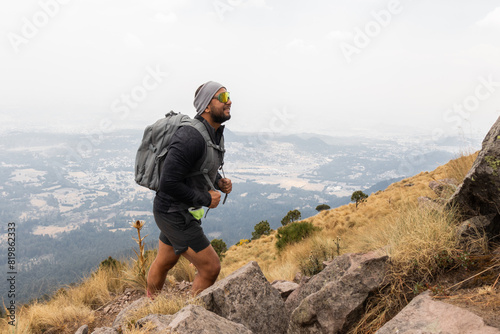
137,305,253,334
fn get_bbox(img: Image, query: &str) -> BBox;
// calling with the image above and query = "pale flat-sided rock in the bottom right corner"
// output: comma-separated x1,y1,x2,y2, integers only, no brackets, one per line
376,292,500,334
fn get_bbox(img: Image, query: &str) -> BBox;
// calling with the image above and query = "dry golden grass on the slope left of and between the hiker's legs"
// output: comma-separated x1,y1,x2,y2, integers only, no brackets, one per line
0,250,198,334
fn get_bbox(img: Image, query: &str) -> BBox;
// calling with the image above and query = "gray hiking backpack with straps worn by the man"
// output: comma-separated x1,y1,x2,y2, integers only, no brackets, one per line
135,111,225,191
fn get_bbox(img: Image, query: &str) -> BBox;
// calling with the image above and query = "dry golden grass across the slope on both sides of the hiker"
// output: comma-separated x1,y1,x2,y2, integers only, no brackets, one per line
0,153,482,333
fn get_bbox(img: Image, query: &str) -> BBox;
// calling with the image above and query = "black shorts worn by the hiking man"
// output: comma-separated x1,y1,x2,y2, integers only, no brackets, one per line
154,210,210,255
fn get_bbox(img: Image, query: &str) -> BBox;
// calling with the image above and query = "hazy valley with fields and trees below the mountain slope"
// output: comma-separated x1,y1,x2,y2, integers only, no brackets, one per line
0,131,480,301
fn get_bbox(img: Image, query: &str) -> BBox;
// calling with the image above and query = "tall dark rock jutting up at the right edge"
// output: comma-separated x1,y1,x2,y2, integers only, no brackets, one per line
448,118,500,237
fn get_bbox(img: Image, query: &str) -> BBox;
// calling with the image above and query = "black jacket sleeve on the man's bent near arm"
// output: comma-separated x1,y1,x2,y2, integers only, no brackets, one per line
160,126,212,206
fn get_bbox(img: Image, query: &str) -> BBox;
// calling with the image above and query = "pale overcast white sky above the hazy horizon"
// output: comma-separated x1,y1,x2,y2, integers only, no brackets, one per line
0,0,500,138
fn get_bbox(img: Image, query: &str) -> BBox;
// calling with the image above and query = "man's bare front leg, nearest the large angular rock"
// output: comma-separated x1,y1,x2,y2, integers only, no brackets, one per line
182,245,220,296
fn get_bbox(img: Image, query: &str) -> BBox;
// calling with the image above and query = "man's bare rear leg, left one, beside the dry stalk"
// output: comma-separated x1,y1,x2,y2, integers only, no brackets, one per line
147,241,180,298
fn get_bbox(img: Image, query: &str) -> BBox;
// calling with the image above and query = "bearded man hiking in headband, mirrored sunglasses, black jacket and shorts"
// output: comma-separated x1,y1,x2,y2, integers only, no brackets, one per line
147,81,232,298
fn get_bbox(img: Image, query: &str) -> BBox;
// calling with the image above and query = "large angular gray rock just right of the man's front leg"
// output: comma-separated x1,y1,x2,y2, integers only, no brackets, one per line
198,261,288,334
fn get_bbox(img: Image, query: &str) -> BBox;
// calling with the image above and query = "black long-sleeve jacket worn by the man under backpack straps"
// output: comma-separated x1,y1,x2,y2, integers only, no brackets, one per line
154,116,224,212
